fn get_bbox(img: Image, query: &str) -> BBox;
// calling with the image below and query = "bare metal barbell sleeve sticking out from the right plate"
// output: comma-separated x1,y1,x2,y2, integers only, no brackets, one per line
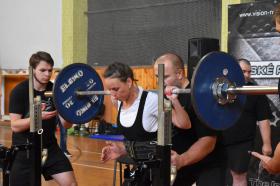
226,86,279,95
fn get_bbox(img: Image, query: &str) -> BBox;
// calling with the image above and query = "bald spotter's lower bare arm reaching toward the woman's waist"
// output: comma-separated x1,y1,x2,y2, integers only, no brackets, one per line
171,136,217,169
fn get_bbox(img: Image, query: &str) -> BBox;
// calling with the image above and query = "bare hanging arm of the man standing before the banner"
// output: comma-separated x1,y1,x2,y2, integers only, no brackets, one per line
259,119,272,155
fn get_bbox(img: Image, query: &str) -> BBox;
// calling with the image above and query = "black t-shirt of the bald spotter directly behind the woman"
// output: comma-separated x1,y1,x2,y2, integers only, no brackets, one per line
172,84,219,166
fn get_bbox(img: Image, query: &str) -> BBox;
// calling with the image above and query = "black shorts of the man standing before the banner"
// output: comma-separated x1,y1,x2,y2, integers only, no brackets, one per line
225,141,254,173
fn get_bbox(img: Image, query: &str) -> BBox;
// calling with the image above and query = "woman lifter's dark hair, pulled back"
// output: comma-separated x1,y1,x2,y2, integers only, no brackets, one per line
103,62,137,82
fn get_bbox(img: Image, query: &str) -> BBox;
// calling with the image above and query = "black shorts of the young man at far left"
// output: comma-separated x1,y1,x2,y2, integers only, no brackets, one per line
10,144,73,186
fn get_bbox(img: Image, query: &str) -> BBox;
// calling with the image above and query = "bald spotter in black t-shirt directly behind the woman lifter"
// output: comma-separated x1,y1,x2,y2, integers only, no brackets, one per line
154,53,223,186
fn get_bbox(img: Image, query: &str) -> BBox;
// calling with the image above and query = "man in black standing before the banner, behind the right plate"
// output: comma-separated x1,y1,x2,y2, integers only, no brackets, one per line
223,59,272,186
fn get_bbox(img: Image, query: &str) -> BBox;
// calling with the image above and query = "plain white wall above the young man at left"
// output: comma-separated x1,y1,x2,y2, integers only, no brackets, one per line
0,0,62,69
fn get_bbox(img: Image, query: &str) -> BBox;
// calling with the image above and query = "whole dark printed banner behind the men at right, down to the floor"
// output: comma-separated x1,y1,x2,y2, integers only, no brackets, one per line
228,0,280,186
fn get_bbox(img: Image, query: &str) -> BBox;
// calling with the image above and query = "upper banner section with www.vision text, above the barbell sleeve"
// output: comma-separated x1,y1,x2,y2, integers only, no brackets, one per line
228,1,280,78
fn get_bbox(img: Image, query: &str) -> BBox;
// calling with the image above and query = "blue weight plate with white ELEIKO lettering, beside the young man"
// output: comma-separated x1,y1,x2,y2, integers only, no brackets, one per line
53,63,104,124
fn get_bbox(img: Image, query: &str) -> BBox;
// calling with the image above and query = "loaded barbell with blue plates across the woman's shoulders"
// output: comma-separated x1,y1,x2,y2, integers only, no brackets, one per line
45,52,278,130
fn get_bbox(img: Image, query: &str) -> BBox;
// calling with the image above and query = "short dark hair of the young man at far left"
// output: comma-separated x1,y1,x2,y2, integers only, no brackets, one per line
29,51,54,68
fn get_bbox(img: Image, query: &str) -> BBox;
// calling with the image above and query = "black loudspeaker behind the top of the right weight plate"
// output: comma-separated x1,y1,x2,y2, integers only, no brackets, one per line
188,38,220,80
